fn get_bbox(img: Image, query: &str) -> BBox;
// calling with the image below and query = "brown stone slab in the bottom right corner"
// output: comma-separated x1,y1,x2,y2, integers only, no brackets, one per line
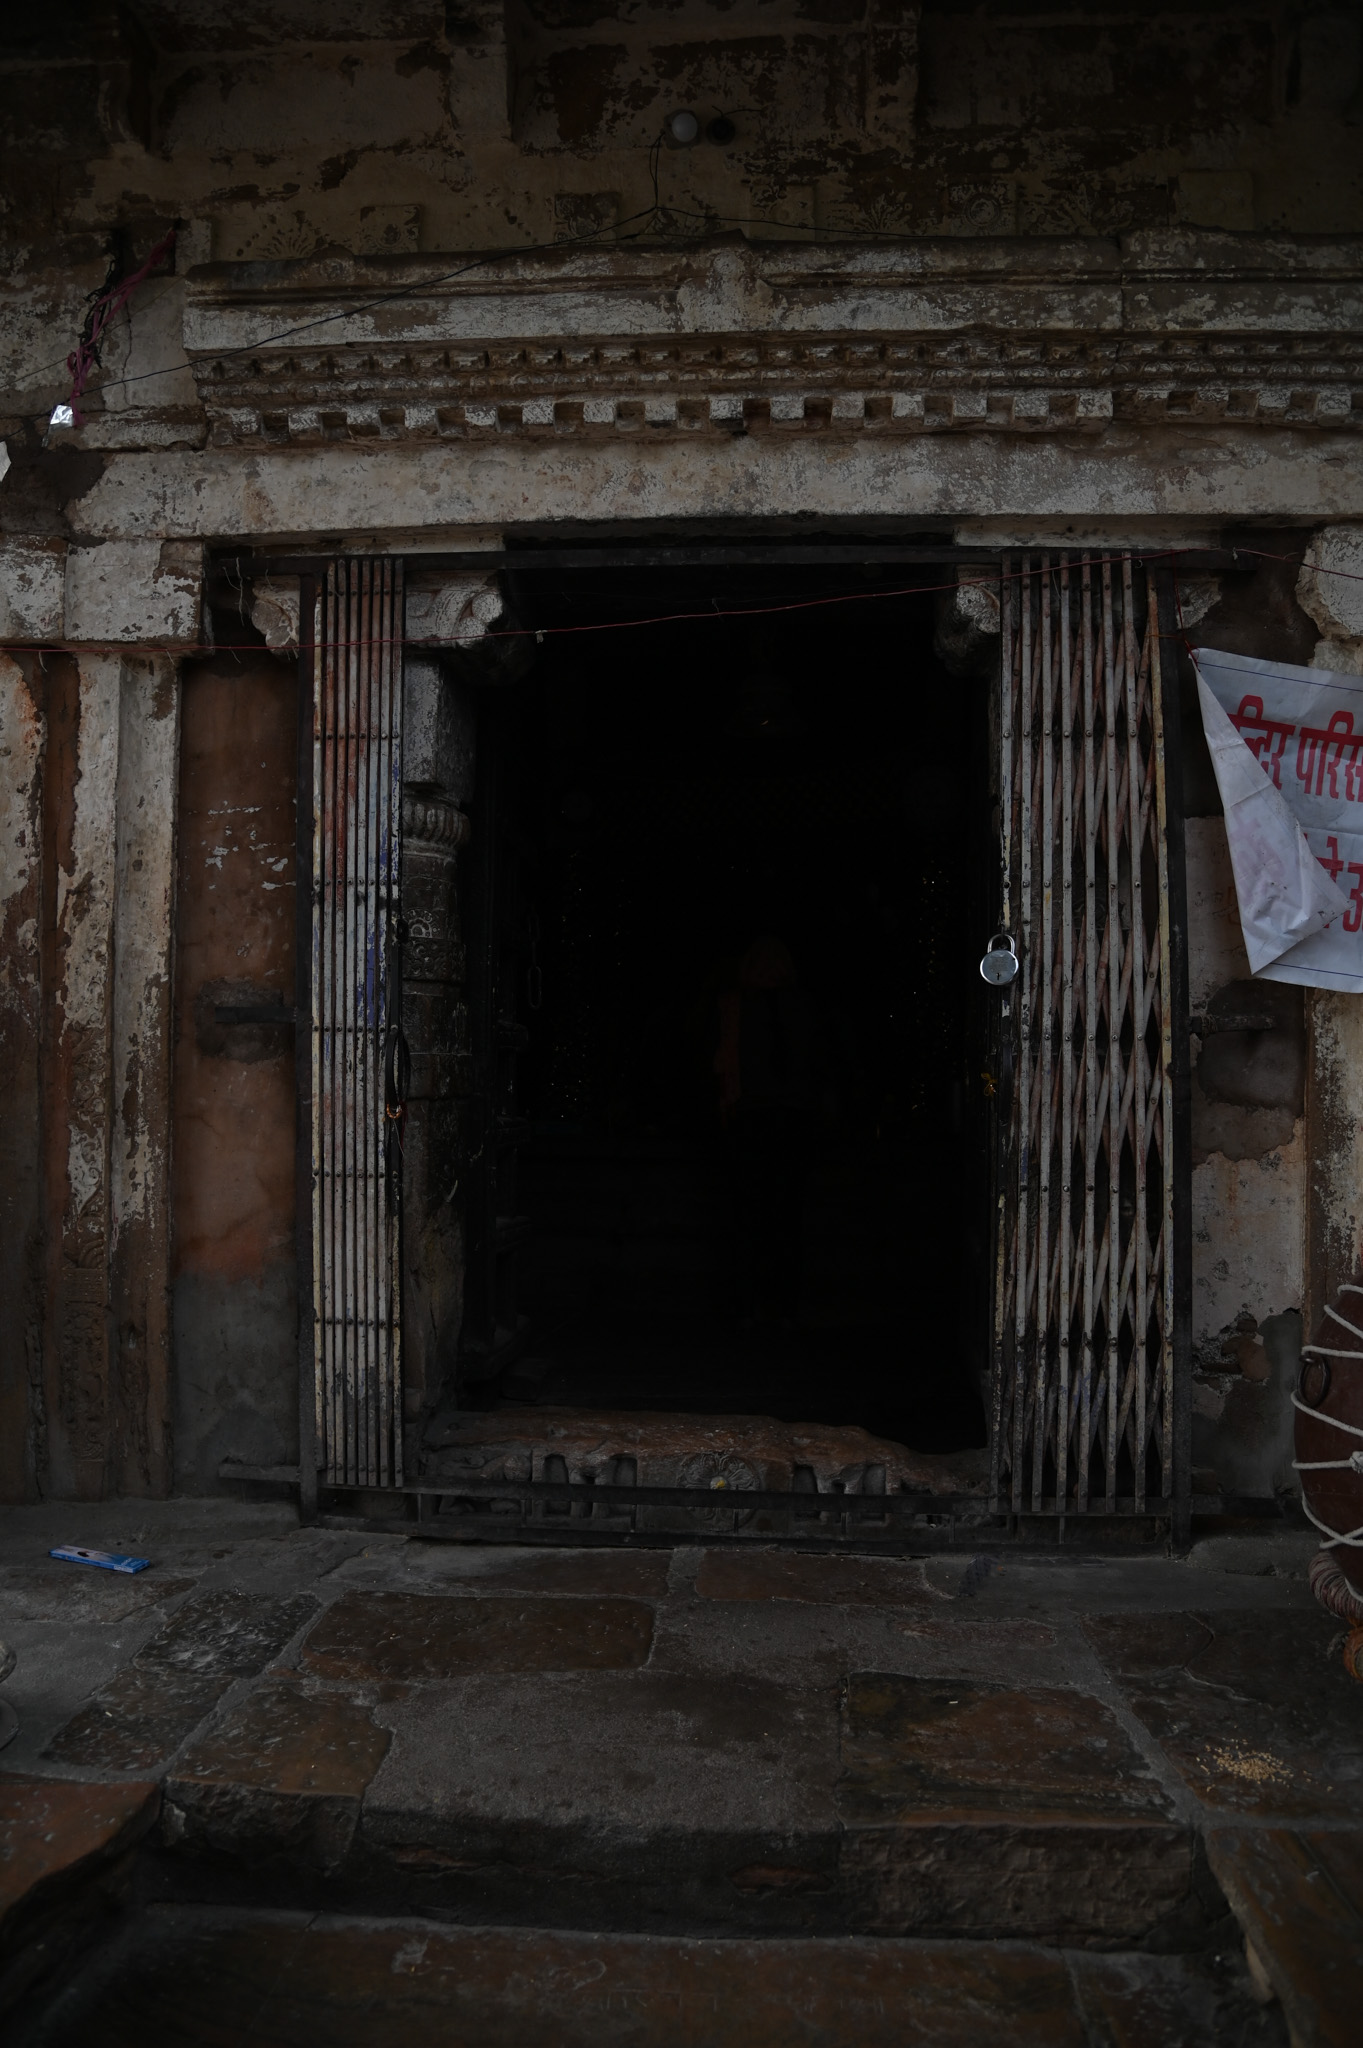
1207,1827,1363,2048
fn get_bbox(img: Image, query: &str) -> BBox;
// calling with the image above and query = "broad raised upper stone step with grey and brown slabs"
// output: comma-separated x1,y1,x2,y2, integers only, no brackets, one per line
143,1561,1195,1948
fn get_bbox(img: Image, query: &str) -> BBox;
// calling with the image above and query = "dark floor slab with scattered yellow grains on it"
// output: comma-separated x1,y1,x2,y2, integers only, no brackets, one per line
1085,1599,1363,1821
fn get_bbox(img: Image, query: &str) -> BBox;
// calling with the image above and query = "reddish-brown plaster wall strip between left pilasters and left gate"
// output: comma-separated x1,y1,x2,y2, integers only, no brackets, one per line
172,651,299,1493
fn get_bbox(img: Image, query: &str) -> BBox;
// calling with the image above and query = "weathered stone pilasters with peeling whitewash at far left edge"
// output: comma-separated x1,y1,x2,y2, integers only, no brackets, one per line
0,630,178,1499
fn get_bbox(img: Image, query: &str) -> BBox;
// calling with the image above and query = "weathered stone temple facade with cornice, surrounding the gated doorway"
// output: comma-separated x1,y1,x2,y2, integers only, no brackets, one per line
0,0,1363,1497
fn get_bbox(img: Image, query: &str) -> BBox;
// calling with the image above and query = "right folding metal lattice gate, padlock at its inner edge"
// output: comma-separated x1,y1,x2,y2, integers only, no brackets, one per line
993,555,1175,1516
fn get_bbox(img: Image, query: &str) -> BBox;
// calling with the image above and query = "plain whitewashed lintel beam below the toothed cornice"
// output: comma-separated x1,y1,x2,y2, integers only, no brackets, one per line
53,434,1359,545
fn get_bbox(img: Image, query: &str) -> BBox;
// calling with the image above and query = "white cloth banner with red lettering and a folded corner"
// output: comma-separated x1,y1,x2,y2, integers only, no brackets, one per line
1195,647,1363,993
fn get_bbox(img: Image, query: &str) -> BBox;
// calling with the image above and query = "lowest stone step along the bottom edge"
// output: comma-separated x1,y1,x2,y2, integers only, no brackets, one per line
14,1907,1283,2048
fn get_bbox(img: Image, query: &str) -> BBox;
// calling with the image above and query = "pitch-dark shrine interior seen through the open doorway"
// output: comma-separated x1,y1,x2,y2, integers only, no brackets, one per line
473,565,991,1450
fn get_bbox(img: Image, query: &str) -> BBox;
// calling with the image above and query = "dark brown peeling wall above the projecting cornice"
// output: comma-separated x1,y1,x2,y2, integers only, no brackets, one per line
4,0,1359,299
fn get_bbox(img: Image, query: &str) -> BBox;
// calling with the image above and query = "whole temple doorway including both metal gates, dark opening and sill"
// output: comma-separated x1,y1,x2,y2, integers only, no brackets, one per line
292,545,1189,1536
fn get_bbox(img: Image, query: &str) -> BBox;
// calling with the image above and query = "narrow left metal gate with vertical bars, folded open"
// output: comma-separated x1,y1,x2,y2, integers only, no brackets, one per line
311,557,403,1487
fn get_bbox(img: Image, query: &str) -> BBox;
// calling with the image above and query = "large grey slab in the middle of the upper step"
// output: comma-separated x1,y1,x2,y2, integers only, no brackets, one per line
339,1671,841,1933
